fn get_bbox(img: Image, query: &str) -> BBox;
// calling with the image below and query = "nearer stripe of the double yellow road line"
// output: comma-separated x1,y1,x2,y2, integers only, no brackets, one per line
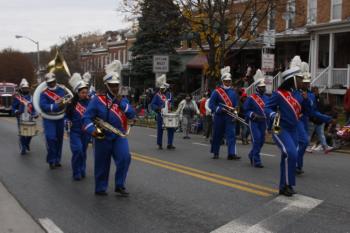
133,156,271,197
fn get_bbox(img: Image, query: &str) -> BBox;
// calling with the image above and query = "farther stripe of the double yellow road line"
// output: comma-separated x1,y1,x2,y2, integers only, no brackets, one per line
132,152,278,193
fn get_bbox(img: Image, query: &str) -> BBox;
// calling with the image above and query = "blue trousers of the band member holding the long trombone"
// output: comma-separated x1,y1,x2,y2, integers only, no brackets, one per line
210,115,237,155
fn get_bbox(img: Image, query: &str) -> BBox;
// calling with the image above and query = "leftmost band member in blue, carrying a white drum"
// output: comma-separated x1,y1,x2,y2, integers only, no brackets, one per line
12,79,37,155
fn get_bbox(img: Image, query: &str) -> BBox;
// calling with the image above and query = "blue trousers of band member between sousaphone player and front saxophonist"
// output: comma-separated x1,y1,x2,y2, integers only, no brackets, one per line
69,131,90,178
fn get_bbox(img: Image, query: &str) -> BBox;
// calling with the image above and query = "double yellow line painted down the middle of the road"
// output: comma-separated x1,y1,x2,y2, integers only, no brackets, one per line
131,152,278,197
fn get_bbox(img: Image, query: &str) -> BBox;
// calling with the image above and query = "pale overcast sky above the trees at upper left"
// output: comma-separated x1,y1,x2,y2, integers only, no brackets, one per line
0,0,127,52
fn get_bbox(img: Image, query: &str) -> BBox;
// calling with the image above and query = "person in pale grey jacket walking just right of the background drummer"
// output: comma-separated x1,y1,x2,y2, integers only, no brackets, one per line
176,94,199,139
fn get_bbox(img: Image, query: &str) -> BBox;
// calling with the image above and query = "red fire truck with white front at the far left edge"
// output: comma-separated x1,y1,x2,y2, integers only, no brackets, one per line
0,82,17,116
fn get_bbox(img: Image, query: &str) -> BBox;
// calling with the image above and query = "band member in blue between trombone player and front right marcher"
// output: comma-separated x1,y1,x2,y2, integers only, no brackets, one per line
243,69,268,168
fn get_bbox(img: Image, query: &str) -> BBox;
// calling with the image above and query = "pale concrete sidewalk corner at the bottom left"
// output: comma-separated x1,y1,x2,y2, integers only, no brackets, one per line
0,182,45,233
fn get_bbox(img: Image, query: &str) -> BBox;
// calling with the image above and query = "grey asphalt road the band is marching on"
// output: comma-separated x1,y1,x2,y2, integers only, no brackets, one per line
0,117,350,233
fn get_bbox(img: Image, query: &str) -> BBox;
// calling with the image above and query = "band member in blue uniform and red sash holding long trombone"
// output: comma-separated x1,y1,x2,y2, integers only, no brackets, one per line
209,66,241,160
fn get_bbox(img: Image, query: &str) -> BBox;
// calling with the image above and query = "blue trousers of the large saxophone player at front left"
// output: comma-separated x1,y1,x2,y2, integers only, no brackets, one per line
94,137,131,192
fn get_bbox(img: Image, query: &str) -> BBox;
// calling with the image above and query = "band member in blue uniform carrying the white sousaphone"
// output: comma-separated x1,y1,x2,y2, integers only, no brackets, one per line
39,73,66,169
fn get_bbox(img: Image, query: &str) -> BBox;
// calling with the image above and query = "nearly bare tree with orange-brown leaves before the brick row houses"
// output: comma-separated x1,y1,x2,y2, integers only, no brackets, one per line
177,0,279,84
